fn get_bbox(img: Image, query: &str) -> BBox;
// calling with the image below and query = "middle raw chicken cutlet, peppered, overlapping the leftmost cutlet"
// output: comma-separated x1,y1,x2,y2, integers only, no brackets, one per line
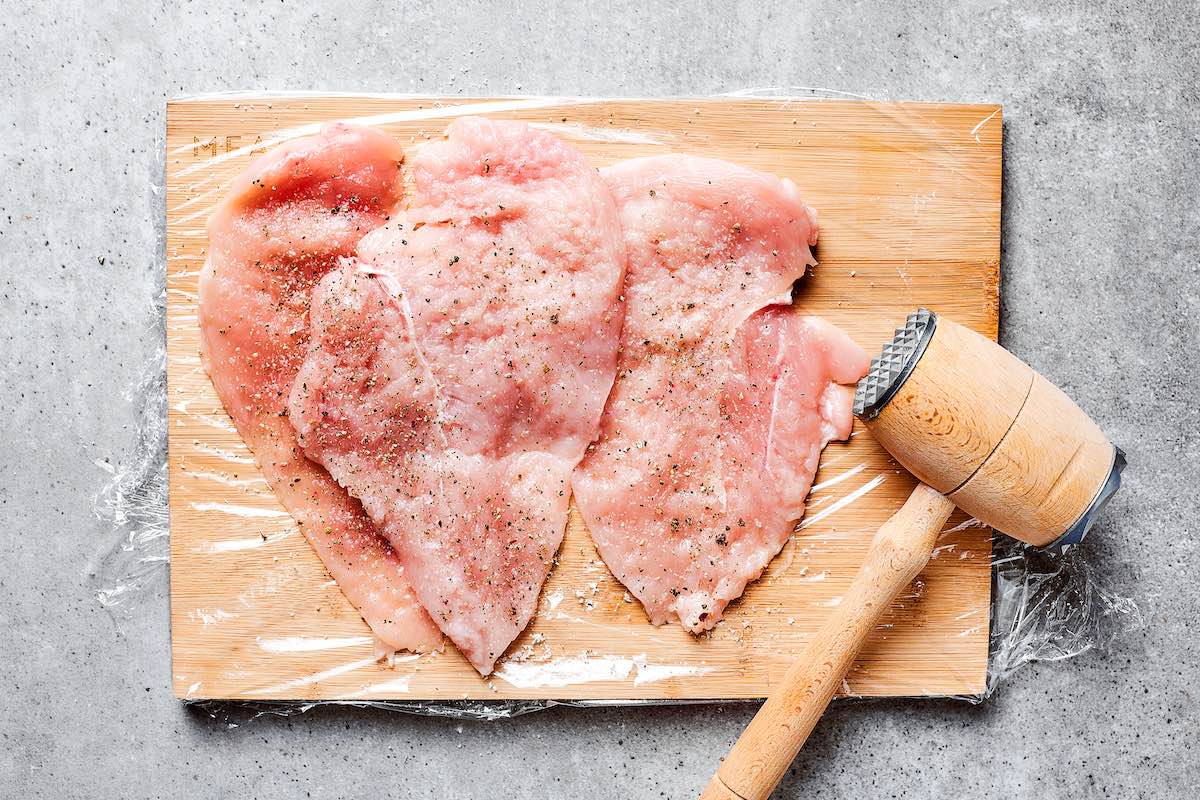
290,119,625,674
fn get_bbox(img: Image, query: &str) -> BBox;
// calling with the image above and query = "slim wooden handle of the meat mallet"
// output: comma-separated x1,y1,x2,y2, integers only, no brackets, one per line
701,483,954,800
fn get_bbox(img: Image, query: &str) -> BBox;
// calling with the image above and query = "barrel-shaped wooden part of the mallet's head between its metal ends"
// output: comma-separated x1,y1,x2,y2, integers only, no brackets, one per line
866,318,1114,547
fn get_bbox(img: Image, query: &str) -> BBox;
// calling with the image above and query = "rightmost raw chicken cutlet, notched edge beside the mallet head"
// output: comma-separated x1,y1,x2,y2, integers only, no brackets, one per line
574,156,868,632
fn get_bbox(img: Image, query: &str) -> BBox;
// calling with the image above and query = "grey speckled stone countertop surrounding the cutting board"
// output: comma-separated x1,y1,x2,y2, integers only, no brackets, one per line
0,0,1200,800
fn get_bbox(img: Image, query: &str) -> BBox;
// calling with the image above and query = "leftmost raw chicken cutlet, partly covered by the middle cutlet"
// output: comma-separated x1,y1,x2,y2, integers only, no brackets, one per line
199,126,442,650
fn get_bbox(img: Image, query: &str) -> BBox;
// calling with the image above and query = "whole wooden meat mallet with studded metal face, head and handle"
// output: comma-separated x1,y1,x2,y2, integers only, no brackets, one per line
701,308,1124,800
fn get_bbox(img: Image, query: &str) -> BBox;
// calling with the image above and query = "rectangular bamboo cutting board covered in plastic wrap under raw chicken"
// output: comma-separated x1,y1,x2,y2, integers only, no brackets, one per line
166,96,1001,700
